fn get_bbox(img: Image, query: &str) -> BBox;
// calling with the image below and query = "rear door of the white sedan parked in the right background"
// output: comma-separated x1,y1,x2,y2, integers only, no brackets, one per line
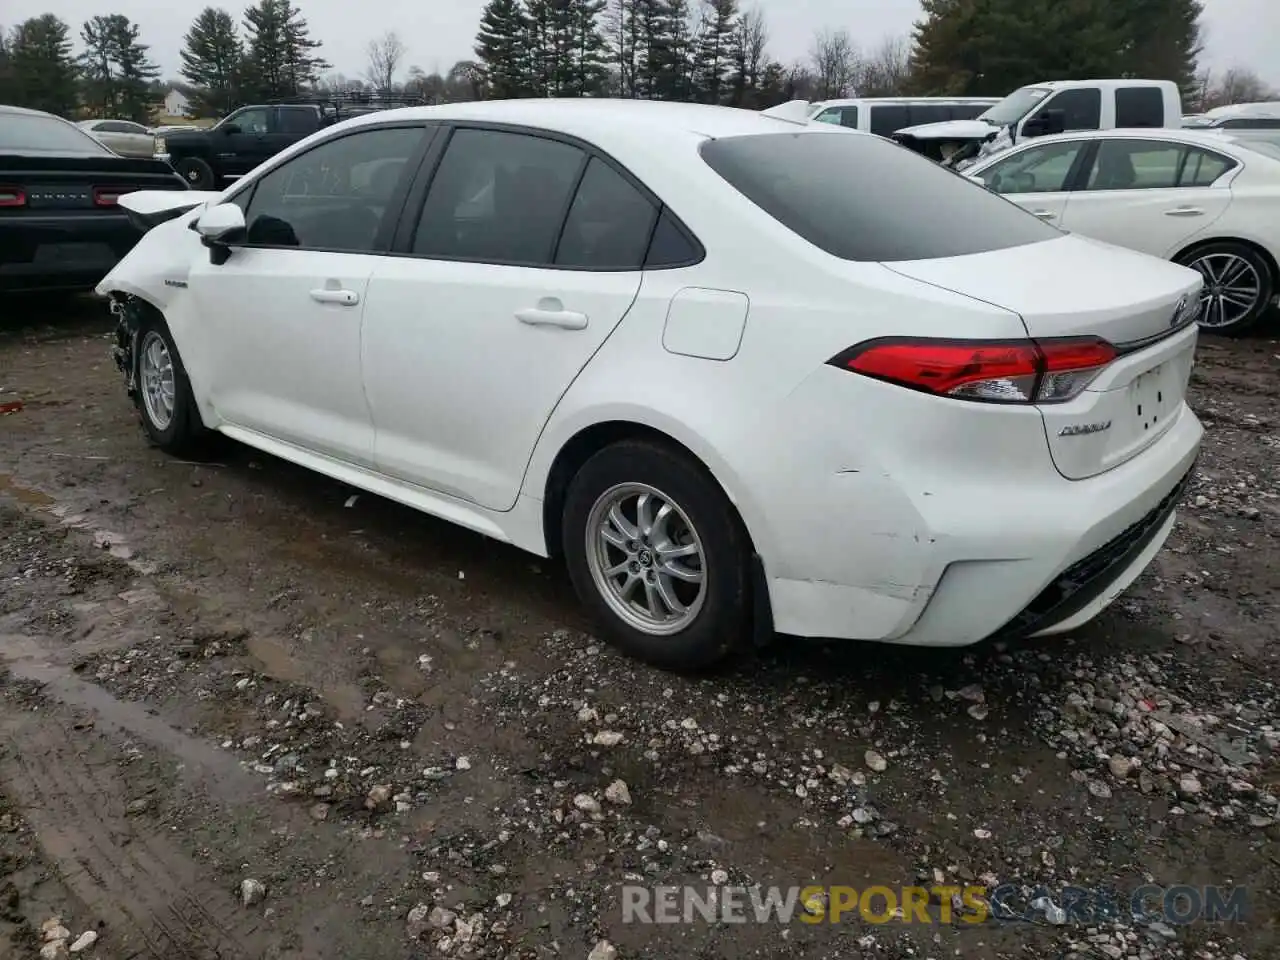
1062,137,1235,257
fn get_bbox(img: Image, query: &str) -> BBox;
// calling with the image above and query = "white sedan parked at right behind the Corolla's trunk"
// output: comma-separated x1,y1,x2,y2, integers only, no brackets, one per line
964,129,1280,334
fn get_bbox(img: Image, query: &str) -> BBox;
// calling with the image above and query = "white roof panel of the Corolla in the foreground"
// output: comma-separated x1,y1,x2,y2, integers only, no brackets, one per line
330,97,856,148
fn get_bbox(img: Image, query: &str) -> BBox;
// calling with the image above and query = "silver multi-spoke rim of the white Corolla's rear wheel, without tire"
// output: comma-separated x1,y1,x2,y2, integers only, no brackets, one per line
586,484,707,636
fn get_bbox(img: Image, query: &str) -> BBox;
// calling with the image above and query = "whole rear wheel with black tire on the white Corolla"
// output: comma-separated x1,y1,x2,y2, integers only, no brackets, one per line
562,440,753,671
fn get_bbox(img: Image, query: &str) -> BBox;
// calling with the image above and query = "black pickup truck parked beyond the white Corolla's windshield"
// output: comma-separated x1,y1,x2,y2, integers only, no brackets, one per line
156,96,426,191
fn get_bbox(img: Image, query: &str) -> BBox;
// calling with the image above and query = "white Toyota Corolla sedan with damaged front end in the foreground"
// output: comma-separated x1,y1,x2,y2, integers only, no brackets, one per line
99,100,1202,668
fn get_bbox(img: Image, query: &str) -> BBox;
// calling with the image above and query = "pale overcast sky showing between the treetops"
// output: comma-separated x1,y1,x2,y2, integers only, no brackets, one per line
0,0,1280,87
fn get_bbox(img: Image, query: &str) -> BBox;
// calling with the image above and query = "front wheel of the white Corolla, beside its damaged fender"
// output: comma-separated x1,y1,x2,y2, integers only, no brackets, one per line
133,314,209,456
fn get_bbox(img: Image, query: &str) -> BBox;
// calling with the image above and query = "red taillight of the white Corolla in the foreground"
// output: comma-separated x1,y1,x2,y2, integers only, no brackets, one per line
828,337,1116,403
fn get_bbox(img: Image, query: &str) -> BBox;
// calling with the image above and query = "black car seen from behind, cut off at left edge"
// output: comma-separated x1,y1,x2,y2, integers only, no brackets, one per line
0,105,187,292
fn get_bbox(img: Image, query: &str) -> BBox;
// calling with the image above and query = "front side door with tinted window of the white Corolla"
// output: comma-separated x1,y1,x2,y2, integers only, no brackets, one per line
187,124,426,467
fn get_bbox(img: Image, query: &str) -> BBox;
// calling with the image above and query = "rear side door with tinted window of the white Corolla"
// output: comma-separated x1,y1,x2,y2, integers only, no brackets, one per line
364,125,658,511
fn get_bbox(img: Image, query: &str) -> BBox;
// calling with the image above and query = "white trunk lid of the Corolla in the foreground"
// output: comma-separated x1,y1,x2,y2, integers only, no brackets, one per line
886,236,1203,480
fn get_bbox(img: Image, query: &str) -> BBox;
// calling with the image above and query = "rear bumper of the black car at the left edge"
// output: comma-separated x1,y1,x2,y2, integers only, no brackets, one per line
0,212,142,292
